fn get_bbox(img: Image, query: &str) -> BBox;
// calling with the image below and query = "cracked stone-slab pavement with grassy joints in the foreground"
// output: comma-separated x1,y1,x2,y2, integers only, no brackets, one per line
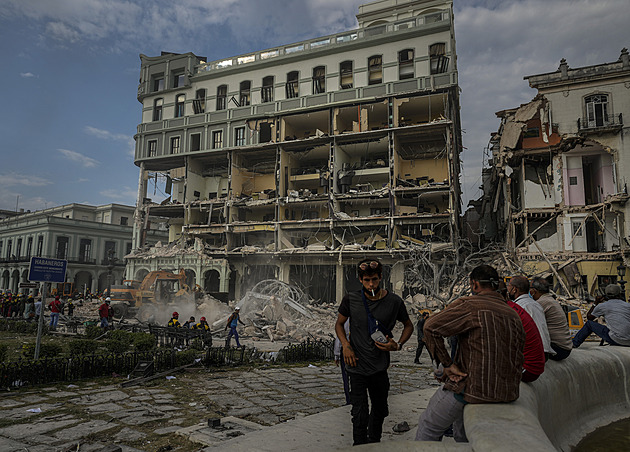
0,347,436,452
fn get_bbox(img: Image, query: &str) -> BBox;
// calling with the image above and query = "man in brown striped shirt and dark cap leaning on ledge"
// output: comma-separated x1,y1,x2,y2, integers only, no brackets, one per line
416,265,525,442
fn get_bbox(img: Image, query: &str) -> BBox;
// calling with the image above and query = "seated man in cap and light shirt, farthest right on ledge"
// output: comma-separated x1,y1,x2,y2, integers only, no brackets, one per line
573,284,630,348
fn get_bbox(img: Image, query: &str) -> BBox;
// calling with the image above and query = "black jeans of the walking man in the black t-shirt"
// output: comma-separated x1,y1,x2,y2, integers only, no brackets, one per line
348,371,389,446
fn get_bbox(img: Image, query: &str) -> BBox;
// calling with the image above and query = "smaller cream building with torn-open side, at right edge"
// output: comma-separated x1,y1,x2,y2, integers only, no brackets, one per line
473,48,630,297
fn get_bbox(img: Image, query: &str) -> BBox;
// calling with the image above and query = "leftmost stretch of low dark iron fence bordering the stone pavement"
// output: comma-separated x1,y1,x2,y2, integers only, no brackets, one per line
0,350,177,389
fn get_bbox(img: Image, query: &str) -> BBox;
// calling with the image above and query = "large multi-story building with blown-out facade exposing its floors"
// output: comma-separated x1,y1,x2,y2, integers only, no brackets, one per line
127,0,461,301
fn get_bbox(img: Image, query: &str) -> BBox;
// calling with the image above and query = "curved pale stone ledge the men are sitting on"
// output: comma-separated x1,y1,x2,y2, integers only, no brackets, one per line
361,343,630,452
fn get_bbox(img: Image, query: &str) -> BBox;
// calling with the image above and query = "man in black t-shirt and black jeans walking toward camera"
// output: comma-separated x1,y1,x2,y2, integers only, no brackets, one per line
335,259,413,445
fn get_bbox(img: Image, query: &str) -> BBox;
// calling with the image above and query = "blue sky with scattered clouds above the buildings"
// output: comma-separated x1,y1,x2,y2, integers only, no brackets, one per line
0,0,630,210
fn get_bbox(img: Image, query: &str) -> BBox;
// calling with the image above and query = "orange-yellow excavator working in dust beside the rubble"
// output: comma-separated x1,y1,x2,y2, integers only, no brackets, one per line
110,269,192,317
